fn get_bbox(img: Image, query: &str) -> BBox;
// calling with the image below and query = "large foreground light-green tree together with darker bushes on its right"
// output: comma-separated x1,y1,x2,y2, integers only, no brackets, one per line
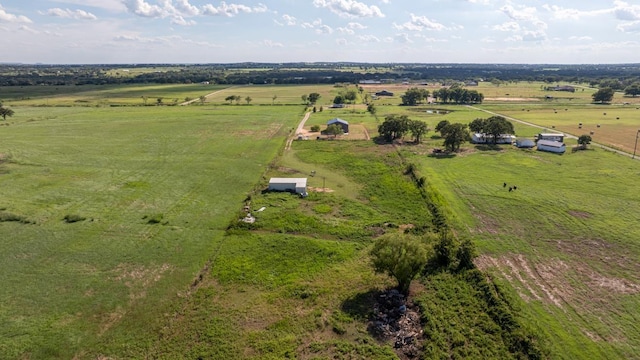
370,231,477,295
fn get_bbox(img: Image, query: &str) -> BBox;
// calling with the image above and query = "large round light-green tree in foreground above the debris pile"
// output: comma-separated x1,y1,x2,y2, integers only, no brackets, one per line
370,233,428,295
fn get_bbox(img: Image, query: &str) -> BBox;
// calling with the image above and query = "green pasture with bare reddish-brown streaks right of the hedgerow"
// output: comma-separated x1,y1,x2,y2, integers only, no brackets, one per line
407,142,640,359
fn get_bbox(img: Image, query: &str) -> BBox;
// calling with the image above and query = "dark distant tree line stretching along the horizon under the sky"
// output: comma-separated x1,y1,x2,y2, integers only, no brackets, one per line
0,63,640,87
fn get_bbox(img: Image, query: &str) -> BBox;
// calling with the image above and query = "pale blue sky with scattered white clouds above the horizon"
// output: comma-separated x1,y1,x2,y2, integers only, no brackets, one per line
0,0,640,64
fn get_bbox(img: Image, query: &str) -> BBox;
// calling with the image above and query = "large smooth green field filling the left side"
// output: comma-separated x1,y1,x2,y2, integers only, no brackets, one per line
0,102,302,359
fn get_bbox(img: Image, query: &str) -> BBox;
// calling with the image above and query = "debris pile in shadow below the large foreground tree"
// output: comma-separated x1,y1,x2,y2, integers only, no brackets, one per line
370,289,422,359
